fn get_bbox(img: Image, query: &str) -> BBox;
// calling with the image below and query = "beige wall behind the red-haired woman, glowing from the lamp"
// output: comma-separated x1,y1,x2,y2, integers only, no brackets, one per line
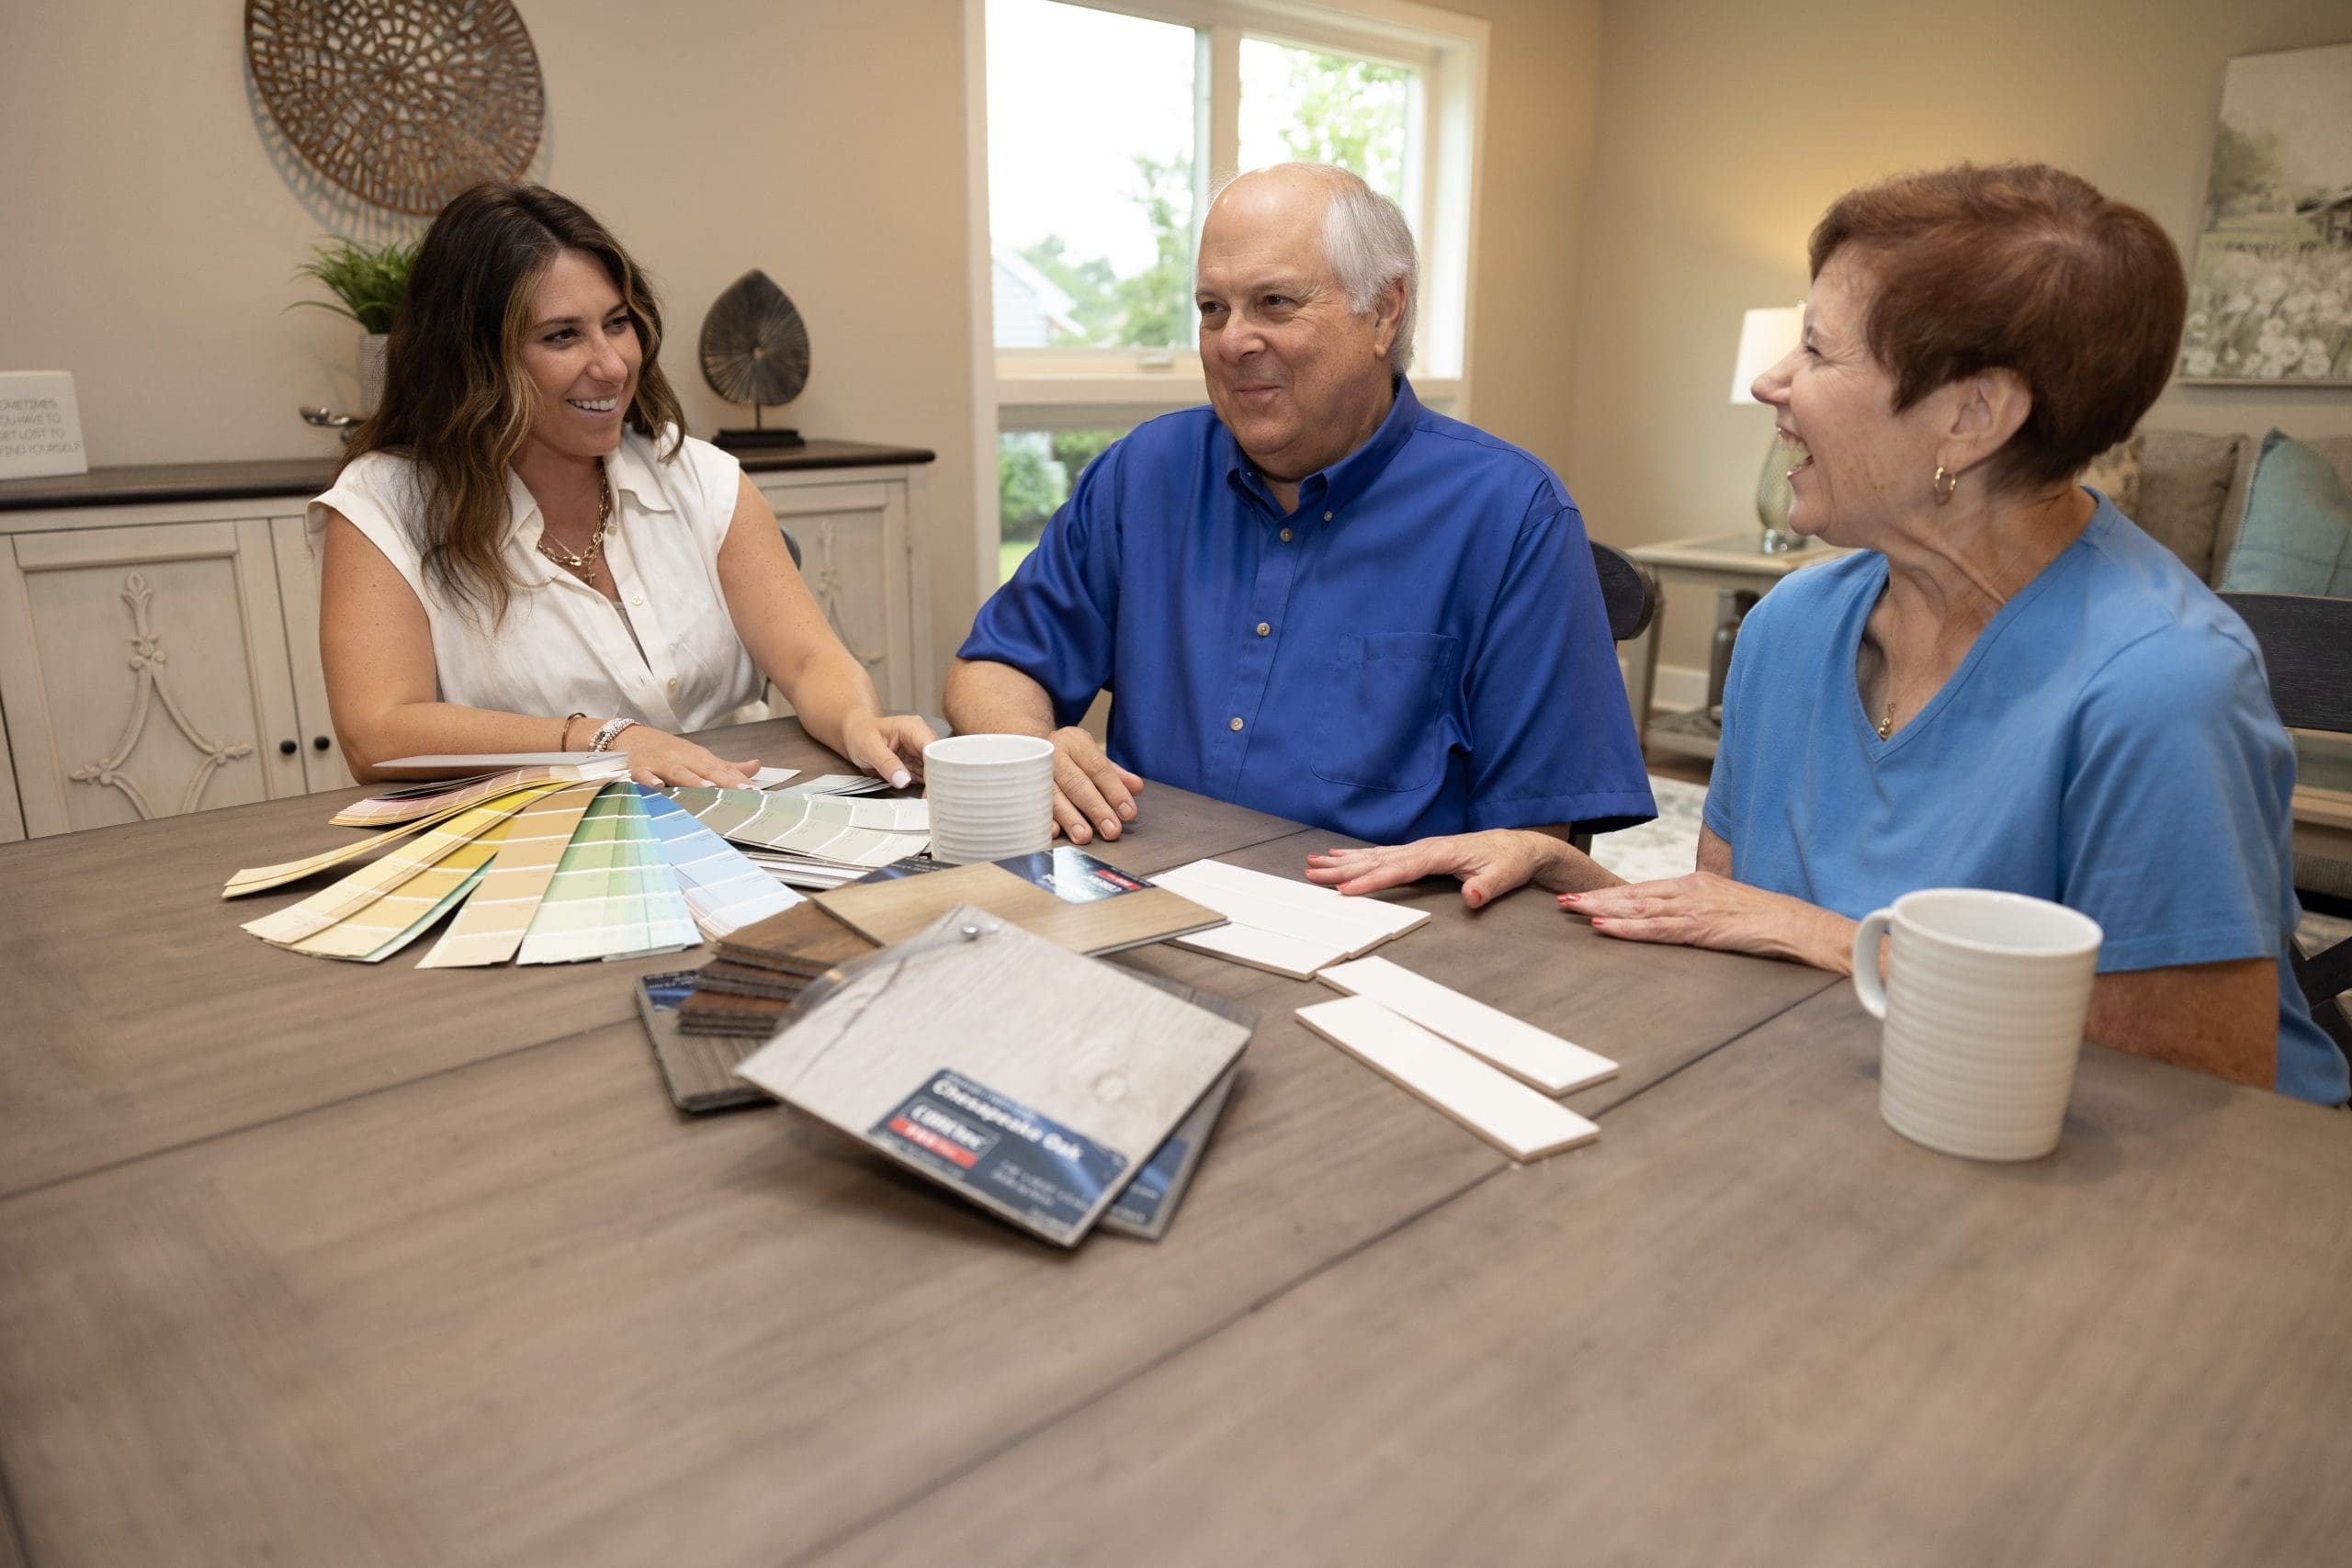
1564,0,2352,665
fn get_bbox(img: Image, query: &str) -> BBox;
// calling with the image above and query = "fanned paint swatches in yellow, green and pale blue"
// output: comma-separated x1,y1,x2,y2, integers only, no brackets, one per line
221,757,799,968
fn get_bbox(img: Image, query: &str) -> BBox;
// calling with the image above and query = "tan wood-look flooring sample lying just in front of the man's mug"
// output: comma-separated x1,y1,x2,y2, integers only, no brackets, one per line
814,844,1226,952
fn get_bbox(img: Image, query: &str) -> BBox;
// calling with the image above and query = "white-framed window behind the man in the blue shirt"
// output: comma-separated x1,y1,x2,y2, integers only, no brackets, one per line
967,0,1487,592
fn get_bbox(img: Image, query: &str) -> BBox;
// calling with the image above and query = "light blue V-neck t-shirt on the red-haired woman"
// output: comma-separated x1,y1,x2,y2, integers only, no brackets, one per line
1708,491,2347,1105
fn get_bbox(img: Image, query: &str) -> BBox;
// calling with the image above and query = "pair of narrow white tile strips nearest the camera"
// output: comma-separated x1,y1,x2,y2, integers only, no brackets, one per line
1298,959,1618,1159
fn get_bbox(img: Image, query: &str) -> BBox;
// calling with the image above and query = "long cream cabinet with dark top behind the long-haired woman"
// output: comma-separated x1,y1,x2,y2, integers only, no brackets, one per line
0,442,938,841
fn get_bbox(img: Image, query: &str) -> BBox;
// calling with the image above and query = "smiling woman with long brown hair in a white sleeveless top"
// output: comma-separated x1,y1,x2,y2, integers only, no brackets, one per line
311,184,932,785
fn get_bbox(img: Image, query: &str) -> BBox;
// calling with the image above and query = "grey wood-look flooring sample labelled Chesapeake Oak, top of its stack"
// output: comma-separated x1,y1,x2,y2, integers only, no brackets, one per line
739,905,1249,1246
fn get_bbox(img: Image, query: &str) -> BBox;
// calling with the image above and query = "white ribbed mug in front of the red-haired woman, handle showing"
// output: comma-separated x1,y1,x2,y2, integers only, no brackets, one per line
1853,888,2100,1159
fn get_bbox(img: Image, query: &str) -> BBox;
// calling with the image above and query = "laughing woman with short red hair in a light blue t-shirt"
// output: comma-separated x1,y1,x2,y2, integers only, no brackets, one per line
1307,164,2347,1105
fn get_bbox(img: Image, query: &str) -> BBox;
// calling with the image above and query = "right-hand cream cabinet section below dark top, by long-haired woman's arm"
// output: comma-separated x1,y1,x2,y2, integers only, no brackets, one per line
752,468,938,712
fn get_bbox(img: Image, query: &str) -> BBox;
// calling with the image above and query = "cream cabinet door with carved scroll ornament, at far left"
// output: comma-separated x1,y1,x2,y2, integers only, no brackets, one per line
0,520,306,835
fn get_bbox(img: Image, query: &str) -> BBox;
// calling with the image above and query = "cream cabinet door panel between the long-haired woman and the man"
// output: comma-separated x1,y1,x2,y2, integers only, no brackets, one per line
760,482,917,712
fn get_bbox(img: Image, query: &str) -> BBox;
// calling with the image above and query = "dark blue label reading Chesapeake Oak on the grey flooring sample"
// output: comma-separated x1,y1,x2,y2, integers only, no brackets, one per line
865,1067,1126,1246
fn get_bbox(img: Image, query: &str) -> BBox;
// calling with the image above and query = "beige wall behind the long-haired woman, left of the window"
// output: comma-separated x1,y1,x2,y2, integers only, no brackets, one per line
0,0,974,667
